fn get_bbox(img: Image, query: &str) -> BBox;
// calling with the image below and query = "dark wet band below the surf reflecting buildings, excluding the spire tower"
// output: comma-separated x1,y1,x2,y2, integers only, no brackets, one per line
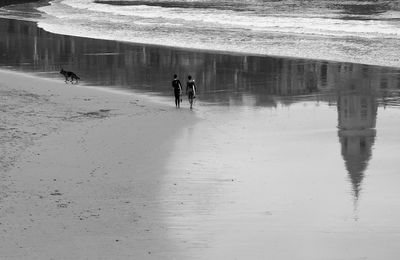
0,19,400,110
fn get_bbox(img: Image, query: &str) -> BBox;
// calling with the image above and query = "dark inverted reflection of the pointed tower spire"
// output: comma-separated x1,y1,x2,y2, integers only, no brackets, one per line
338,76,377,202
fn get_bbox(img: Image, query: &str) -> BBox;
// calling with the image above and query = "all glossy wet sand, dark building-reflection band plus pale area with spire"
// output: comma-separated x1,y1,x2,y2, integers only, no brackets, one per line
0,19,400,259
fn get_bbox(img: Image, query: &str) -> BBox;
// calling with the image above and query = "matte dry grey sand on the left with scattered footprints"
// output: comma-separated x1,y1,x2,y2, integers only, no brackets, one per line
0,68,196,259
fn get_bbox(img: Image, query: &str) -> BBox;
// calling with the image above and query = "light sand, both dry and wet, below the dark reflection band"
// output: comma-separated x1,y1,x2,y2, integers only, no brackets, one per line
0,67,400,259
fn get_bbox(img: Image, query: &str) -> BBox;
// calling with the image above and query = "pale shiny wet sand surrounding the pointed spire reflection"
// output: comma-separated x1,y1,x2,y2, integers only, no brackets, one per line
160,101,400,259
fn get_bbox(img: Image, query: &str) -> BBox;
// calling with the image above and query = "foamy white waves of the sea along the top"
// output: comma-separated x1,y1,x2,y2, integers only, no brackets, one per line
2,0,400,67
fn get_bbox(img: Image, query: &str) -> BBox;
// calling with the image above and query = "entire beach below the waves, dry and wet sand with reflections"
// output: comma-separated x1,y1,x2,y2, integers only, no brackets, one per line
0,1,400,260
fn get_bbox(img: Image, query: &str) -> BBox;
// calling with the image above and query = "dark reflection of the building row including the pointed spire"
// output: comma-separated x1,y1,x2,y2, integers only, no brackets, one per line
0,19,400,203
